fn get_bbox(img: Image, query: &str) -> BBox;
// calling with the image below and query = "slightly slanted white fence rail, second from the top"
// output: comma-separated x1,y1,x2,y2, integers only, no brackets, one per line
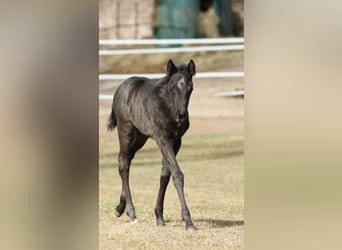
99,45,244,56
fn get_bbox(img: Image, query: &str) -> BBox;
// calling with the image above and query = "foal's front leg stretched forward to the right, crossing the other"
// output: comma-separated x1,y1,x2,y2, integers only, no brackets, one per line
157,137,196,230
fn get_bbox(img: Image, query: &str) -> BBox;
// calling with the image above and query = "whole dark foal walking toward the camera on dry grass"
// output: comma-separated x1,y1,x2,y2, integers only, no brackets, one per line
108,60,196,230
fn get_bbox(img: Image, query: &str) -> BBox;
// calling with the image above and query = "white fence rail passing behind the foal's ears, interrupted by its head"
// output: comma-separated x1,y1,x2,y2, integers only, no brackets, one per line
99,72,245,80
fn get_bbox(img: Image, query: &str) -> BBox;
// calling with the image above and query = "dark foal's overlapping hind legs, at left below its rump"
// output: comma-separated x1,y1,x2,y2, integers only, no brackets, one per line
115,123,147,221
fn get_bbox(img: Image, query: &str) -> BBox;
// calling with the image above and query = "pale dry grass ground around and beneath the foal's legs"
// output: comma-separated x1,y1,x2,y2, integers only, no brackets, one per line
99,131,244,249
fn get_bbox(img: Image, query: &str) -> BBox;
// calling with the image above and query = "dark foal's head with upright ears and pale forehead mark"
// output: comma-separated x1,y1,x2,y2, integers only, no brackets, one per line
166,60,196,117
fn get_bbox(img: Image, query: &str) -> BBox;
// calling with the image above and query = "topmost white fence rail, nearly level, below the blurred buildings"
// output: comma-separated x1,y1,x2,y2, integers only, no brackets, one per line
99,37,245,45
